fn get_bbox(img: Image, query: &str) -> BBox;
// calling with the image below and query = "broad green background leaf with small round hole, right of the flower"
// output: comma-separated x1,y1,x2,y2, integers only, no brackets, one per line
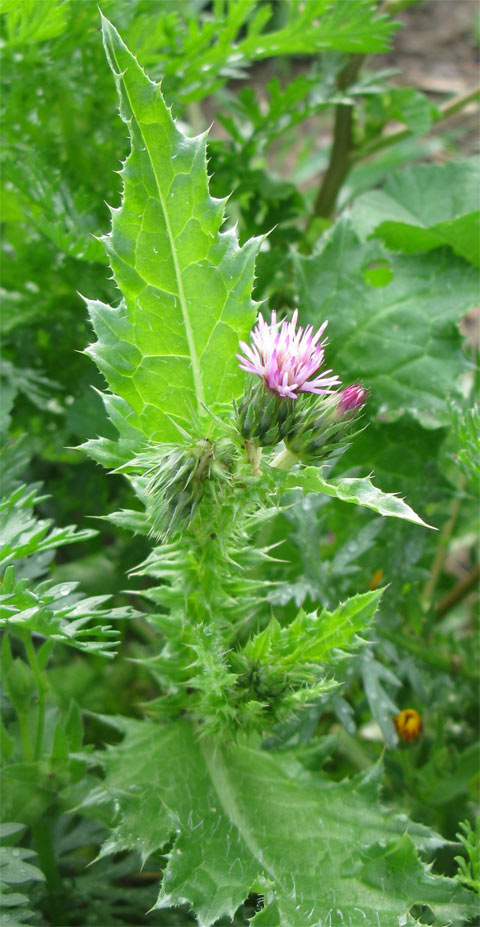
295,218,478,428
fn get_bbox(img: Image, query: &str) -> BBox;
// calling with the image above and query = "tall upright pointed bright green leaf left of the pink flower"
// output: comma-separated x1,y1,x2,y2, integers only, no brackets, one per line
89,19,259,450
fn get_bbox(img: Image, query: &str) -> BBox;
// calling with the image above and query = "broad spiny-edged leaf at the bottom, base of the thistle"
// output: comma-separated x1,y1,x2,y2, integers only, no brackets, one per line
83,718,474,927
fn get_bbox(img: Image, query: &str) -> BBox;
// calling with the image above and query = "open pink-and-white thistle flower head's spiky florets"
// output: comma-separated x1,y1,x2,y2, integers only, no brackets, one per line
237,309,341,399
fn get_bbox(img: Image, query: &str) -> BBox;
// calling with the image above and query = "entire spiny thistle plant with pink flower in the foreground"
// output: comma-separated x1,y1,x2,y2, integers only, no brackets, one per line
67,21,480,927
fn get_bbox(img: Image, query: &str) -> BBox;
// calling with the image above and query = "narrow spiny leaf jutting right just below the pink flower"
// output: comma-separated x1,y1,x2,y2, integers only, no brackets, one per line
266,467,431,528
